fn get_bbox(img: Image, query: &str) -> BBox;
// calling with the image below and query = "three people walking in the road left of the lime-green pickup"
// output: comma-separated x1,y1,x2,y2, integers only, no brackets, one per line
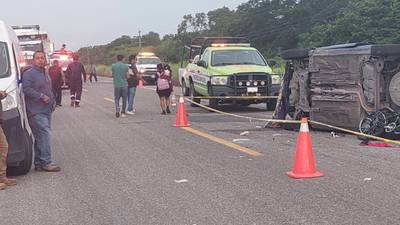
111,55,173,118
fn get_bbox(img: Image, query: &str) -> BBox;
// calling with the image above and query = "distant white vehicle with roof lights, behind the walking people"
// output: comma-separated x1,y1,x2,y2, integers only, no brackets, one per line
136,52,161,84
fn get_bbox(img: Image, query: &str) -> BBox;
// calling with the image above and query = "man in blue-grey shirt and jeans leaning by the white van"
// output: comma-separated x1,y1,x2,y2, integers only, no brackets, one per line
22,51,61,172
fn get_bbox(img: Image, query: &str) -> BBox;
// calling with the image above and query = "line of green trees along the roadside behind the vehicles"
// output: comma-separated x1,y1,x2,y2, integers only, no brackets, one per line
79,0,400,64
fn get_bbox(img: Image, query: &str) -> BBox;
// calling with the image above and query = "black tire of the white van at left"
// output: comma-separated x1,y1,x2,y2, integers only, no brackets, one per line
7,131,33,176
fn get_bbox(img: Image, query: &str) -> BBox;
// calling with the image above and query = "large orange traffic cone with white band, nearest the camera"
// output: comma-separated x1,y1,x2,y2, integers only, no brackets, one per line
286,118,324,179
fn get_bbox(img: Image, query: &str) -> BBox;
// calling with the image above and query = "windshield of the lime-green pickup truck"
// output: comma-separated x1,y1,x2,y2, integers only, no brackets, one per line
211,50,266,66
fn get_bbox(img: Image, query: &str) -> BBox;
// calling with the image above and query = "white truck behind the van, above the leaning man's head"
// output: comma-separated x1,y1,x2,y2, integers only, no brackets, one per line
12,25,54,64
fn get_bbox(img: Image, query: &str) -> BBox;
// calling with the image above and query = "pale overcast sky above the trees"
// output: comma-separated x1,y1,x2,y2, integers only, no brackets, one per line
0,0,248,50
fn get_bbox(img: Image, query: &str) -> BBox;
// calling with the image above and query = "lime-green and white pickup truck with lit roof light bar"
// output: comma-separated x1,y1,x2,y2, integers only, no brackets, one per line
179,37,281,110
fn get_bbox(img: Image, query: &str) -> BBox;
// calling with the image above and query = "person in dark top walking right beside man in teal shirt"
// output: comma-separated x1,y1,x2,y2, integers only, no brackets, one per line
126,55,139,115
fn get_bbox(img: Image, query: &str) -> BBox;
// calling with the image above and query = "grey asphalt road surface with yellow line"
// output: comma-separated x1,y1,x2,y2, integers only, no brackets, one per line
0,79,400,225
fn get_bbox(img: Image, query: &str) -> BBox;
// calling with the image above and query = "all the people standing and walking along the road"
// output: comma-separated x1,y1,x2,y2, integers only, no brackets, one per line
0,51,173,190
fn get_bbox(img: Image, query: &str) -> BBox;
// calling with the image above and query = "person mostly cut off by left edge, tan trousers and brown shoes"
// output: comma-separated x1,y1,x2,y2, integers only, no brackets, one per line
0,91,17,190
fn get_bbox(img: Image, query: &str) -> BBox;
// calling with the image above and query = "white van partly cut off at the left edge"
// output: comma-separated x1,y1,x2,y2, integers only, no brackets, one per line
0,20,33,175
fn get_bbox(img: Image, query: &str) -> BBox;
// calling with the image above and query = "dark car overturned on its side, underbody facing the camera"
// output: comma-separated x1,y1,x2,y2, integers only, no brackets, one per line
281,43,400,134
